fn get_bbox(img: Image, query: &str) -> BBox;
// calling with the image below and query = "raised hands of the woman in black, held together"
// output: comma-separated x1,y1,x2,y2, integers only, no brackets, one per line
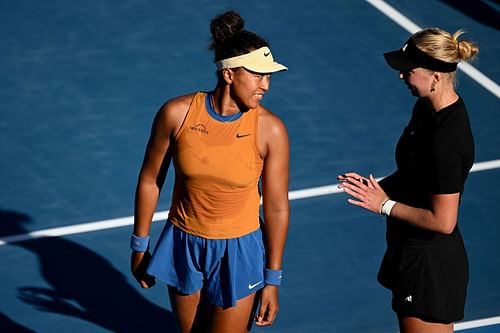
337,172,389,214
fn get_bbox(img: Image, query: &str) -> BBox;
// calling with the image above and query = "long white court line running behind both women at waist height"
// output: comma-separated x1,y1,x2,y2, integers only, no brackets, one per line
0,159,500,246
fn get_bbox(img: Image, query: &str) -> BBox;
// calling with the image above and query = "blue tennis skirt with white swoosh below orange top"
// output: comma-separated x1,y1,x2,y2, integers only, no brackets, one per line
147,221,265,308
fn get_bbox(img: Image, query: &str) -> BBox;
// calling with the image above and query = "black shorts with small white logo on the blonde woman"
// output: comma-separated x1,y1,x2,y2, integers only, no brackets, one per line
377,230,469,324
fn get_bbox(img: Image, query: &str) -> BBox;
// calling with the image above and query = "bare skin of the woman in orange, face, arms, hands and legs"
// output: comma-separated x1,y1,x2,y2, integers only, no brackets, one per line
131,68,289,333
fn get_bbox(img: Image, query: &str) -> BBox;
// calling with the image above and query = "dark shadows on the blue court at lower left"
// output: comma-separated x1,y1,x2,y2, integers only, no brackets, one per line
0,210,175,333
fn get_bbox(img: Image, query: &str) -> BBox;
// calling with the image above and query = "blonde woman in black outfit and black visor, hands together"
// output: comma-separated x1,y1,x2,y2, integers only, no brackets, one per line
338,28,479,333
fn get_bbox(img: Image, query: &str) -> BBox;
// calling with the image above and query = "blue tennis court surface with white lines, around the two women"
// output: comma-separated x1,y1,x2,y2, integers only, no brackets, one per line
0,0,500,333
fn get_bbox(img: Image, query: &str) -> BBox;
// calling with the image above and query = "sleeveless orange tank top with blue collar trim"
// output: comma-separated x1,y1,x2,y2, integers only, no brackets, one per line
169,92,263,239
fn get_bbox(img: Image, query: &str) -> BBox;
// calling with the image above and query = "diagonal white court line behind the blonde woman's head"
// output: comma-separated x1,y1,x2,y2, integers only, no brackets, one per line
366,0,500,98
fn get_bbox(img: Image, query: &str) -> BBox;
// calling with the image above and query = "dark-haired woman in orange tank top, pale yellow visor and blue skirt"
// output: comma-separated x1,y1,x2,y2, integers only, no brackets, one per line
131,11,289,333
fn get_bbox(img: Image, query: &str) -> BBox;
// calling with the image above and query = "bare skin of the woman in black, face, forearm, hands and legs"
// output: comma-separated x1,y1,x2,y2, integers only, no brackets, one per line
337,68,460,333
